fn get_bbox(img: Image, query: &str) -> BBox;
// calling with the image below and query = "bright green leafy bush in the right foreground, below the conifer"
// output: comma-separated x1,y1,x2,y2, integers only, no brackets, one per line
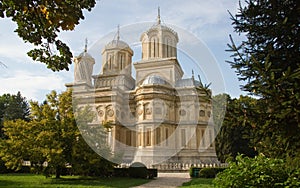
213,155,290,187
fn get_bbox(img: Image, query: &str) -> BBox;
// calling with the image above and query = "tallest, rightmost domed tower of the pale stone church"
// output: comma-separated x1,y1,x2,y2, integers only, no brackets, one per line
134,9,183,85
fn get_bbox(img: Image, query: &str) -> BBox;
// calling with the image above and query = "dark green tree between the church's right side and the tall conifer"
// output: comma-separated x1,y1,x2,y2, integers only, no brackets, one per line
214,95,257,162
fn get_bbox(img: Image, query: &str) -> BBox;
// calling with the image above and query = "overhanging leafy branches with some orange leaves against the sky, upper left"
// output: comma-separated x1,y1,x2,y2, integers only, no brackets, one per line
0,0,96,71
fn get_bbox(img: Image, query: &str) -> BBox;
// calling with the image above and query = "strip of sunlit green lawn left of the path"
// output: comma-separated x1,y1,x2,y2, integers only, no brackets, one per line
0,174,150,188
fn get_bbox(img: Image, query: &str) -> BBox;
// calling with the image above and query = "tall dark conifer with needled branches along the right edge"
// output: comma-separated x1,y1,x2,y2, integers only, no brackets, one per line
229,0,300,158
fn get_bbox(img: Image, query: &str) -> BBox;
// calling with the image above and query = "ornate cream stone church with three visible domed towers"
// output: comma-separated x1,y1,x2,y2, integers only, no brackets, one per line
66,9,218,165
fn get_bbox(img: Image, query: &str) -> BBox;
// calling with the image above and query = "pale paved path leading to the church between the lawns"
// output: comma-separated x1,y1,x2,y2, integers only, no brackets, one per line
135,173,191,188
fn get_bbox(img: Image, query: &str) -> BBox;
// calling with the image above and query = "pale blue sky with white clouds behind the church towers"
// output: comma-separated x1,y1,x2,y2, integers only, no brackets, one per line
0,0,244,102
